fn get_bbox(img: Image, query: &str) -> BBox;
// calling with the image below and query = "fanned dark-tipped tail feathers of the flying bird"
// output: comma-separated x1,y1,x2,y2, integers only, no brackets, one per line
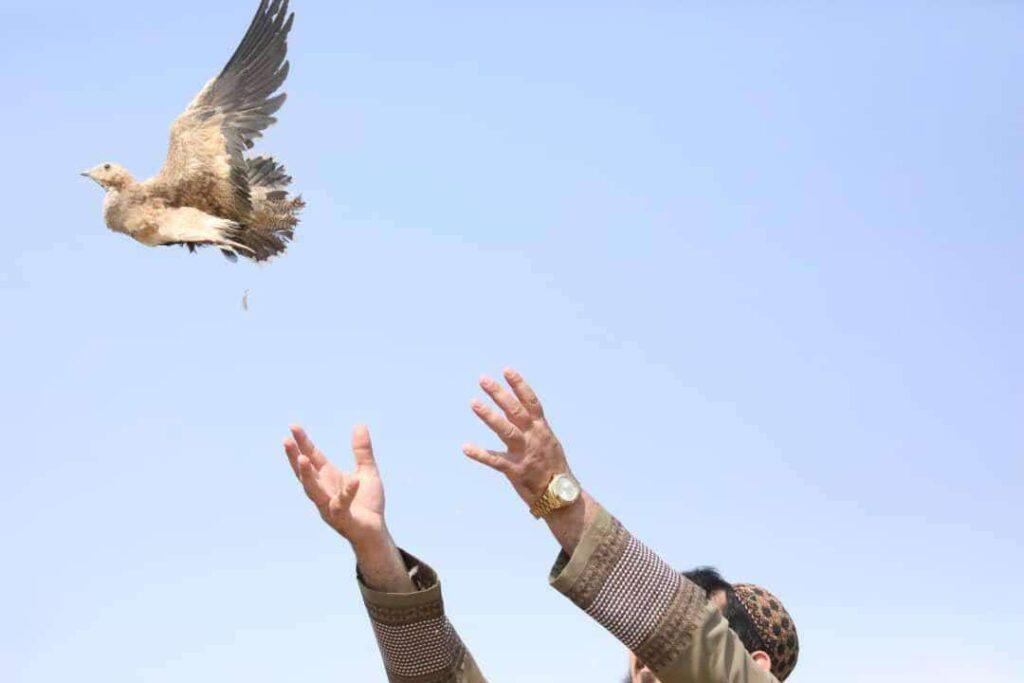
234,157,306,261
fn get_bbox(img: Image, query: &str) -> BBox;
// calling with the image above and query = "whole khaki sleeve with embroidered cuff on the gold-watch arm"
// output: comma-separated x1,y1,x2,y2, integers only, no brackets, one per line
550,510,775,683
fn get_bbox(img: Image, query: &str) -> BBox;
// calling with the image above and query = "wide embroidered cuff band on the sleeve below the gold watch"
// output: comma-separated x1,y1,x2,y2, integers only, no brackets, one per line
549,509,708,675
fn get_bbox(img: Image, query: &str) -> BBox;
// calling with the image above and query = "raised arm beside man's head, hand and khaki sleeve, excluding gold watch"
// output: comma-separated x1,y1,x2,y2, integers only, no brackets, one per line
464,371,775,683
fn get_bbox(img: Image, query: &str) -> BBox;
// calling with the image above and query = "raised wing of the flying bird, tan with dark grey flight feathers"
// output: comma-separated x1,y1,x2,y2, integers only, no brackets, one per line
153,0,295,218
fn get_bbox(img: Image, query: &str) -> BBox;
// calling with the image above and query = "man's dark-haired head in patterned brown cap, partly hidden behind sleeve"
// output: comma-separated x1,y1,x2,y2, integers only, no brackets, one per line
627,567,800,683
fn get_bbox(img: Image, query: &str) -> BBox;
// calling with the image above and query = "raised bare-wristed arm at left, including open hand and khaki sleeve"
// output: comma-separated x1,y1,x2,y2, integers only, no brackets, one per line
285,427,485,683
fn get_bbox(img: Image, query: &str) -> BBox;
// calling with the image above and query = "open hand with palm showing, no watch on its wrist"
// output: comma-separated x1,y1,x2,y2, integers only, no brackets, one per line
285,426,386,545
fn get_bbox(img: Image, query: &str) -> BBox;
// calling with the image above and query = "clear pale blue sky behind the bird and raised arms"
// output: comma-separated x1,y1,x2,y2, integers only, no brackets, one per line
0,0,1024,683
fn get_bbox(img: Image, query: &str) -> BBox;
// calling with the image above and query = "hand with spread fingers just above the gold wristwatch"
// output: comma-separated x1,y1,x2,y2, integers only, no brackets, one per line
463,370,569,505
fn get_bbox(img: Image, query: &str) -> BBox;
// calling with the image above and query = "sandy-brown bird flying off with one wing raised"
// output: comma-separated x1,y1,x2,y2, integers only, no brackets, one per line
81,0,305,262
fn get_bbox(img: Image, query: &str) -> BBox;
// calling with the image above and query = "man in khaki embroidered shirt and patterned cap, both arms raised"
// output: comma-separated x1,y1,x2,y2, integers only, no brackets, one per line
285,370,800,683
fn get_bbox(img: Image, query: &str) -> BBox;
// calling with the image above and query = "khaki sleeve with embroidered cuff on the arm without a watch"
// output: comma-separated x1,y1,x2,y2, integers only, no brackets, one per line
358,551,486,683
